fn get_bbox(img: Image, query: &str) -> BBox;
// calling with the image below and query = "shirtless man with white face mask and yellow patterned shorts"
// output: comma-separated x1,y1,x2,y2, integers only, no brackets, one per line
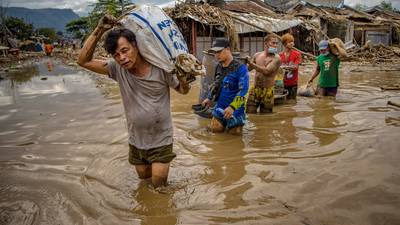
246,34,281,113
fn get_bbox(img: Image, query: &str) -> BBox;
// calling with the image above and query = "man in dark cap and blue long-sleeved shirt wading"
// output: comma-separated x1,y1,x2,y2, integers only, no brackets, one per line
202,38,249,134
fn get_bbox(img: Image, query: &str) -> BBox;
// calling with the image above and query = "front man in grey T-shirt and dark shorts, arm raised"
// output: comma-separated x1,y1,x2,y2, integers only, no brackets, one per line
78,16,190,187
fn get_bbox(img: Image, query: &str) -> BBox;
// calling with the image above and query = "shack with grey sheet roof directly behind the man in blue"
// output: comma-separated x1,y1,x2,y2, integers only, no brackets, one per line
165,1,301,59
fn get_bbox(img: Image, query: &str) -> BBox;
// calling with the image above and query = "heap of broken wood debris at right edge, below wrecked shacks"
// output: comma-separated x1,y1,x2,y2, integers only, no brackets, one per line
348,41,400,63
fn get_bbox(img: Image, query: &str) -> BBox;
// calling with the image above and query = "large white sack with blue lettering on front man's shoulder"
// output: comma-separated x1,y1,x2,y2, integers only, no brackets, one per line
119,5,205,82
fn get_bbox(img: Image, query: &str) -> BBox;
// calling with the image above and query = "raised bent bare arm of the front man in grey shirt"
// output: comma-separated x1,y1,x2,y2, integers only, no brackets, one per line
77,16,113,75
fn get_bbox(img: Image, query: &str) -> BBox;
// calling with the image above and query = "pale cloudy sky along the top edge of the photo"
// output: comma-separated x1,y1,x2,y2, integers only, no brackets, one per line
0,0,400,15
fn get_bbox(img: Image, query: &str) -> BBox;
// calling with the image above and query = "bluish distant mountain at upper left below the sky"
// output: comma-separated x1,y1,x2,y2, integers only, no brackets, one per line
5,7,79,31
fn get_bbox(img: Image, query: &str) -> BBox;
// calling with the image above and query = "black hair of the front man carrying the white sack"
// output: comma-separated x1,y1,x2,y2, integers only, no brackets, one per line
104,28,136,55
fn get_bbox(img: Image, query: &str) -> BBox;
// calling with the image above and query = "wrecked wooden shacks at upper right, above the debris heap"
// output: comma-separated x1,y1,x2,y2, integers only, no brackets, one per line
287,3,400,46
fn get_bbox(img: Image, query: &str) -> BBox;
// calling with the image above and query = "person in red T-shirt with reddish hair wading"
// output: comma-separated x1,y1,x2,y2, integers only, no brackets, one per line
279,34,301,100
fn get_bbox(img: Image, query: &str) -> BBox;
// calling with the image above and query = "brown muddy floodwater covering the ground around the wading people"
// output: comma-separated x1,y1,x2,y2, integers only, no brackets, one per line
0,59,400,225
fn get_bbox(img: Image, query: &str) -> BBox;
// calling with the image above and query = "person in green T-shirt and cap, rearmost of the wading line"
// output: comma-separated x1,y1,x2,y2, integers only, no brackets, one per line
308,40,346,97
